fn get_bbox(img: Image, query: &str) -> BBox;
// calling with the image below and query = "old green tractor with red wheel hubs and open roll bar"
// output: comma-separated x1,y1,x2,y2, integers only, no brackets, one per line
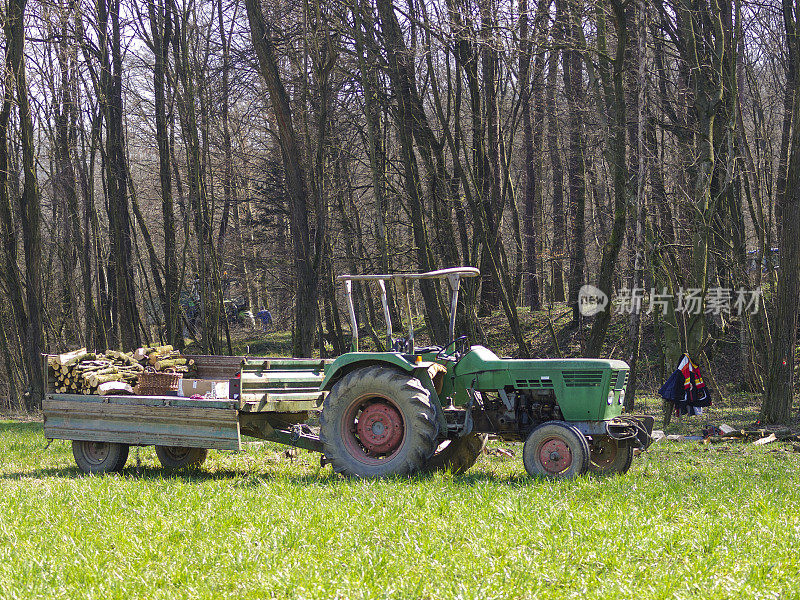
319,267,653,478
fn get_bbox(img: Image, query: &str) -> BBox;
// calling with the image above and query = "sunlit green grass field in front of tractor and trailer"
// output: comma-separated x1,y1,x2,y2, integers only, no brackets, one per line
0,421,800,600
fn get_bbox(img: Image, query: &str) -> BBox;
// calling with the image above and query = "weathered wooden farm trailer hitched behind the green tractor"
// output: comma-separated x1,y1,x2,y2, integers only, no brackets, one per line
43,356,331,473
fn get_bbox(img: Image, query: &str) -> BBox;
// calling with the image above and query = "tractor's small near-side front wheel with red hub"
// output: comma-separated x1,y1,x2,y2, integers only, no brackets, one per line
522,421,589,479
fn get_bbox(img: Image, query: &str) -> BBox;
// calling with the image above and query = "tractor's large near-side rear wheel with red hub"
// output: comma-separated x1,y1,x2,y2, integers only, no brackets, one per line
319,366,439,478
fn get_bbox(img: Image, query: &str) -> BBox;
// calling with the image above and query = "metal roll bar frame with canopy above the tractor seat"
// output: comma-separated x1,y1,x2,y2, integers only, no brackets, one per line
337,267,481,352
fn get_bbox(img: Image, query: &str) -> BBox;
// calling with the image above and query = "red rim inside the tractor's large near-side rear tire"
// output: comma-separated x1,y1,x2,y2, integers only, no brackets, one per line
342,395,405,464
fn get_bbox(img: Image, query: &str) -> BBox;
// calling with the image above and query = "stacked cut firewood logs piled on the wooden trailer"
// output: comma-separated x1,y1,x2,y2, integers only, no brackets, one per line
49,346,194,394
